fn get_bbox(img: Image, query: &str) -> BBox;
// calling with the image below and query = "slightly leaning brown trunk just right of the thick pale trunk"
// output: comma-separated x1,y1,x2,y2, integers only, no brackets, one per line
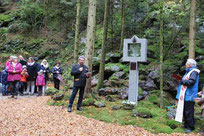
97,0,109,89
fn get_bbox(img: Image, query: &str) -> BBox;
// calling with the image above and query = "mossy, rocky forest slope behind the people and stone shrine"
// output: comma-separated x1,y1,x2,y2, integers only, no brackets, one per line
0,0,204,133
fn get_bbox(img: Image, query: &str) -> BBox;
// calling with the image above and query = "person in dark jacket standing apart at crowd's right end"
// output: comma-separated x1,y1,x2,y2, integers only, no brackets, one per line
52,62,62,90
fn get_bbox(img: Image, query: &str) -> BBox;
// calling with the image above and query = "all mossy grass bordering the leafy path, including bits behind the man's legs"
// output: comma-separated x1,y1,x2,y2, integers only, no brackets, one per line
47,90,203,134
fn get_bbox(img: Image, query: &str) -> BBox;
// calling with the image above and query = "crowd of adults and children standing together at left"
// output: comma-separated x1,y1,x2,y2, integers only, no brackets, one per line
0,55,62,98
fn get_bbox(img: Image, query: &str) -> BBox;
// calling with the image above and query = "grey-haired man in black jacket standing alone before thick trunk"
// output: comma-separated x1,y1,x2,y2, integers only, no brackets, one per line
68,56,91,112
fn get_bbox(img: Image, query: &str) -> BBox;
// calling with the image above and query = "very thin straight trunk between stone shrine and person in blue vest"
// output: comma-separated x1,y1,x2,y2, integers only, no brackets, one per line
160,2,164,108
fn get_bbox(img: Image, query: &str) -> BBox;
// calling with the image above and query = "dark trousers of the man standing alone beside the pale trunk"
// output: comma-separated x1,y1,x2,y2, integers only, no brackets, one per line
68,86,84,108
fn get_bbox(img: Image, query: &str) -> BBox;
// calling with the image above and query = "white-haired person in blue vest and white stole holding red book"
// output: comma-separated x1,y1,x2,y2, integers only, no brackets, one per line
176,59,200,133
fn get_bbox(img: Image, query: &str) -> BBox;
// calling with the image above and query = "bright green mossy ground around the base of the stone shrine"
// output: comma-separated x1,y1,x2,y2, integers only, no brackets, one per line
76,100,200,134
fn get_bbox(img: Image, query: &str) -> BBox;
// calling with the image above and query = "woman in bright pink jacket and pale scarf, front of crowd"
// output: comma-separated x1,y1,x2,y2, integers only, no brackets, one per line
7,56,22,98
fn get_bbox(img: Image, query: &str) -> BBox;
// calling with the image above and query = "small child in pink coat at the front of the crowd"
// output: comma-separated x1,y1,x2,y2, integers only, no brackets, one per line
36,70,45,96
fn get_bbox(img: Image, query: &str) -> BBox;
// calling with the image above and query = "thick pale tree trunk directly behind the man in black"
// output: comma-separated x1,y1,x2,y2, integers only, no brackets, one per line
85,0,96,93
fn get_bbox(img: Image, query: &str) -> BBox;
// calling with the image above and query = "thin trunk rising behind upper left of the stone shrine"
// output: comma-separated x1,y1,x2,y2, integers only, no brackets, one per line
120,0,126,51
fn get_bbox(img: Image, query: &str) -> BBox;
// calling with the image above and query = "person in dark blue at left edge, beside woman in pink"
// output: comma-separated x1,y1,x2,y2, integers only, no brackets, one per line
0,69,9,96
